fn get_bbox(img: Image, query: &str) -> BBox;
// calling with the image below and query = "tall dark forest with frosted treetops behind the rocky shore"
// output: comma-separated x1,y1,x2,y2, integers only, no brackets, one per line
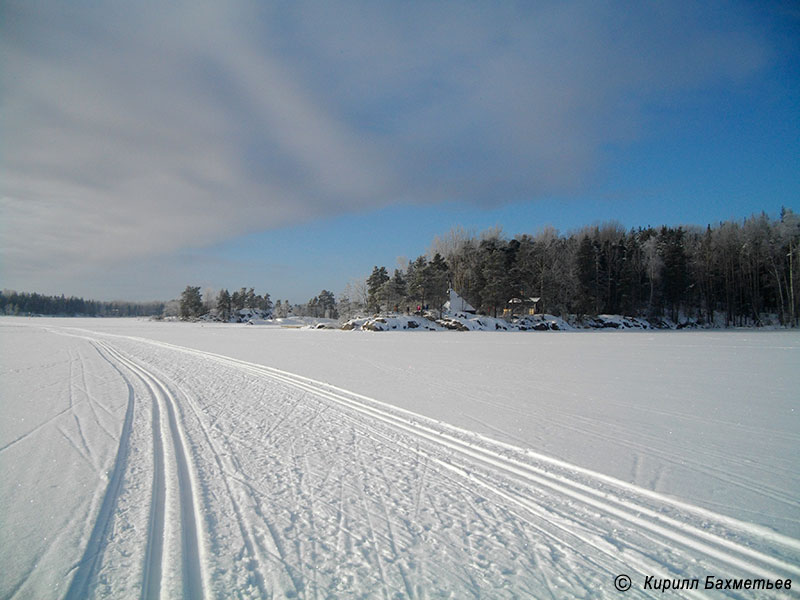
348,209,800,326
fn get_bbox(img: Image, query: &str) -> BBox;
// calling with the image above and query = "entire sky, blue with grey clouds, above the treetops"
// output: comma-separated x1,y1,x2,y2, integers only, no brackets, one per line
0,0,800,302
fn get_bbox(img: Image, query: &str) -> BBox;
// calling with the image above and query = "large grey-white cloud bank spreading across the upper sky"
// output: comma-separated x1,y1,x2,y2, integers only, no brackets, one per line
0,1,768,296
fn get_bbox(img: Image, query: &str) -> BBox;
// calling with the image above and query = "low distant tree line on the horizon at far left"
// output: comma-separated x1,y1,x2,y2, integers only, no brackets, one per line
0,290,164,317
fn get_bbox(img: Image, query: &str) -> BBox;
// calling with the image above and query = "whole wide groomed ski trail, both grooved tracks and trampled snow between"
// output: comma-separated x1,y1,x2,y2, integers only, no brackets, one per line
2,329,800,598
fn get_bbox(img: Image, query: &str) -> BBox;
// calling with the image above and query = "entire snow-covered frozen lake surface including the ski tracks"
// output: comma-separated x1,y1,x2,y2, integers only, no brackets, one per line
0,318,800,598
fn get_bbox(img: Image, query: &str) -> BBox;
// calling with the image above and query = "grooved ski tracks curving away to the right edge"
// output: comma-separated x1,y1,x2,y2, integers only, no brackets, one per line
117,338,800,579
